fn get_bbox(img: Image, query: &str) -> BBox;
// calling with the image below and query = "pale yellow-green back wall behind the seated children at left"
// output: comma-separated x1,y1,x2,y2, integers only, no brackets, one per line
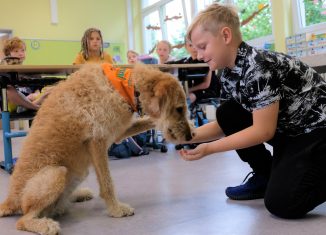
0,0,128,64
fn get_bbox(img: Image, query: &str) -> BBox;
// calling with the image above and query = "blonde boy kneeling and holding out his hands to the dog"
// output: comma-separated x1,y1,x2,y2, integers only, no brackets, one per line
180,3,326,218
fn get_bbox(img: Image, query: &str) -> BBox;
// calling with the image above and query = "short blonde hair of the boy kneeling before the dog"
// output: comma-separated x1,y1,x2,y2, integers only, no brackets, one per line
186,3,242,41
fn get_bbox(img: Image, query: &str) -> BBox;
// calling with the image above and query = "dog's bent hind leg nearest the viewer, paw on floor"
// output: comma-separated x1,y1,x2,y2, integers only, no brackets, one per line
16,166,67,235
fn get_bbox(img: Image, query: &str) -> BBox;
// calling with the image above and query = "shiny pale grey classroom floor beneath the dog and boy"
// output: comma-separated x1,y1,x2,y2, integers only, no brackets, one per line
0,132,326,235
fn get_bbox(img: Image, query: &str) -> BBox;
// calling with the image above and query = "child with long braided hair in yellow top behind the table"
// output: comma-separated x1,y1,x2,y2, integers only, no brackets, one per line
73,28,114,65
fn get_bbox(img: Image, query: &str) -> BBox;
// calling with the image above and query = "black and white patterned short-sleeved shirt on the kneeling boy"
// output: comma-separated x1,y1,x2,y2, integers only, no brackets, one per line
221,42,326,136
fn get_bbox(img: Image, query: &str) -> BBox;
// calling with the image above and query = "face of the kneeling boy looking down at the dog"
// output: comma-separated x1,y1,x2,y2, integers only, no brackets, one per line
190,26,231,70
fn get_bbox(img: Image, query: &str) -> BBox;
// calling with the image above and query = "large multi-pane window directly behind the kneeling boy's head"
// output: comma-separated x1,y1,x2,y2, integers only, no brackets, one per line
142,0,273,58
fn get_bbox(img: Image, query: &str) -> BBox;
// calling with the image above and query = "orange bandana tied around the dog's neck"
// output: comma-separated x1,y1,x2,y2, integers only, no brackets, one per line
101,63,137,111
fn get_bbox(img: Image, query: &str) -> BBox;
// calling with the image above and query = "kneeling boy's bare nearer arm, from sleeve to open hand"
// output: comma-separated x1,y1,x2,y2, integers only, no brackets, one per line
180,102,279,160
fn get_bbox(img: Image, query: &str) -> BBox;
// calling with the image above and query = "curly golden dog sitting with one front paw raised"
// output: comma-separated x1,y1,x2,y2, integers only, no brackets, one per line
0,65,194,235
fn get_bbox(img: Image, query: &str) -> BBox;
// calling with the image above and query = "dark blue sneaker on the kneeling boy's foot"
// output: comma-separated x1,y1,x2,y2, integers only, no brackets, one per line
225,172,268,200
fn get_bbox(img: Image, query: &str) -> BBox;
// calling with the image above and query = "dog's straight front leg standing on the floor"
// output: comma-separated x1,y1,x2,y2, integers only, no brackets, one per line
89,139,134,217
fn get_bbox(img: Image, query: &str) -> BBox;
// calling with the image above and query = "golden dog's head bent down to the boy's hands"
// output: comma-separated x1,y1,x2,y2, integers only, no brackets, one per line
133,65,194,143
